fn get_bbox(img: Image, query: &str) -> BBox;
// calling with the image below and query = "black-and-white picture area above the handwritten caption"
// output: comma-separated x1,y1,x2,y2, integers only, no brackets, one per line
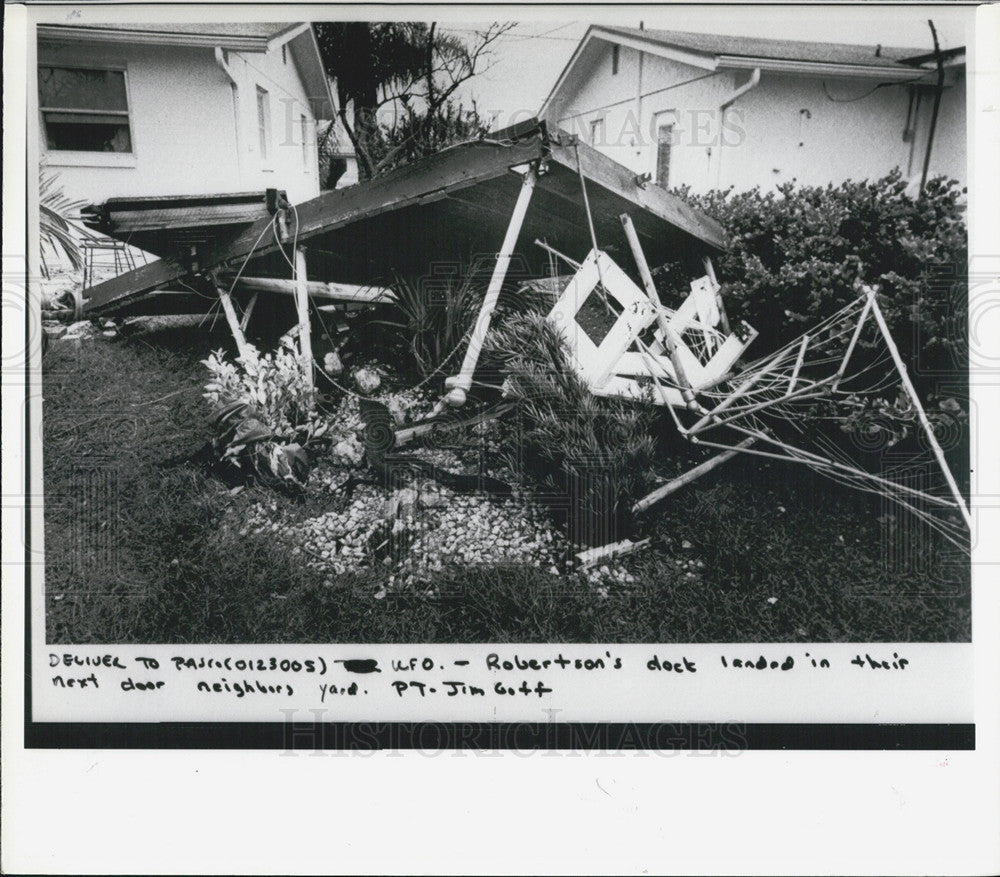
37,10,972,643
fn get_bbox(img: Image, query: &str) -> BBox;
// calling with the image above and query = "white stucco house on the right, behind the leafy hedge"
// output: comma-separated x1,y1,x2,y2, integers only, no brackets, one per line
540,26,967,192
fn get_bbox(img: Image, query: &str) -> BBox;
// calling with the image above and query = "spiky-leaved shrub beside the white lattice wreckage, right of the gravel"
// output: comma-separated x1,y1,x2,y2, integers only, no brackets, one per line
487,313,656,544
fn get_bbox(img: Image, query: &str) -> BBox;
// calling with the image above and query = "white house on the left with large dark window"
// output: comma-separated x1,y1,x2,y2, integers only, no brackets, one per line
36,22,333,203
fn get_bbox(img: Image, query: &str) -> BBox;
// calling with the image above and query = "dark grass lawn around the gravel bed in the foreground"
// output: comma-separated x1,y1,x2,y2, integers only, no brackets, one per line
43,321,970,643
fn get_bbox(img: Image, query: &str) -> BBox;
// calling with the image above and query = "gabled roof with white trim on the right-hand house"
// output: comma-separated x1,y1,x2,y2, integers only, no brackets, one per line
539,25,962,117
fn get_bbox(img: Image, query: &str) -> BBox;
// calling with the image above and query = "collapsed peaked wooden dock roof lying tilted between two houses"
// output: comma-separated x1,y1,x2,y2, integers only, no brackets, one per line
78,120,725,316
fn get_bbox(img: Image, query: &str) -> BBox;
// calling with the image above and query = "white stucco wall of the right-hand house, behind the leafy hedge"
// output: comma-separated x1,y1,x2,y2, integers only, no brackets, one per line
553,43,967,192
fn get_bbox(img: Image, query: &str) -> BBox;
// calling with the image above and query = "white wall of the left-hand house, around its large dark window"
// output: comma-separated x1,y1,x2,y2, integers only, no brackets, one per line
38,41,319,203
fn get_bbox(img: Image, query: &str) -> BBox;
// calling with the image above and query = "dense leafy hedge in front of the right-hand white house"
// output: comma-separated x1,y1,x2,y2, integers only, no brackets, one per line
659,170,968,370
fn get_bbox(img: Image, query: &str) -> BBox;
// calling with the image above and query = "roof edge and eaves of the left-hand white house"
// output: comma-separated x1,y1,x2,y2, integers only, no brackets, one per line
38,21,334,119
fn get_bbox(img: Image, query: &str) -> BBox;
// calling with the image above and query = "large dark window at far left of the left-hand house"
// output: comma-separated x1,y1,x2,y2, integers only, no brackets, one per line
38,67,132,152
